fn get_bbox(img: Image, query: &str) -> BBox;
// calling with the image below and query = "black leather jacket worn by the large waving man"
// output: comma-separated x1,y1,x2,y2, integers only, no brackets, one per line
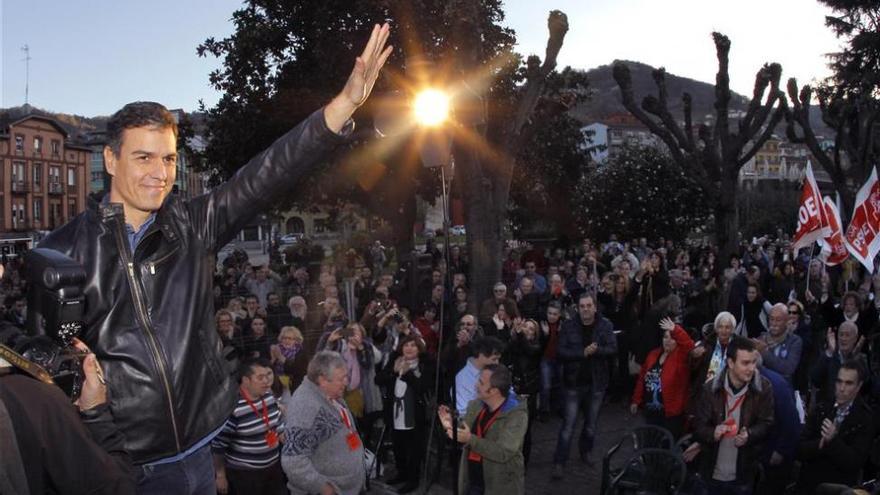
40,109,350,464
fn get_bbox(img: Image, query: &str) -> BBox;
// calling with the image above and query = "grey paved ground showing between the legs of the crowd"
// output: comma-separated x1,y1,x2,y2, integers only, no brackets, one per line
369,403,641,495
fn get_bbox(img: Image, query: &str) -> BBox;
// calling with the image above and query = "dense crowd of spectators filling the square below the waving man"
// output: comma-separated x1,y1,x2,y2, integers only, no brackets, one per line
43,231,852,493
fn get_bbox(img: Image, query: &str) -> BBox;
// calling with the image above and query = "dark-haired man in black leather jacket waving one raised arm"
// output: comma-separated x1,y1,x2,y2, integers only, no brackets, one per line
41,24,391,495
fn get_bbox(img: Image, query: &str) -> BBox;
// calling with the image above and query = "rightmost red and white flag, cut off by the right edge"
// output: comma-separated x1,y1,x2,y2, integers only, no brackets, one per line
844,169,880,273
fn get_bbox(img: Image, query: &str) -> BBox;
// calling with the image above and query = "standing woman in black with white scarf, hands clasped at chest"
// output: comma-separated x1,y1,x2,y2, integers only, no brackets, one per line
376,333,433,493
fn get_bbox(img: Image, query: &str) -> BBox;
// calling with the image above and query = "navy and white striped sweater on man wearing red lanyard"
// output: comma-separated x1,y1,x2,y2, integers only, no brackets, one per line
211,392,284,469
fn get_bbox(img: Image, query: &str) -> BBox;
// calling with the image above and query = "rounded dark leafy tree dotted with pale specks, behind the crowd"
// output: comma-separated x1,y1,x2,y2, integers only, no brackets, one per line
575,146,712,240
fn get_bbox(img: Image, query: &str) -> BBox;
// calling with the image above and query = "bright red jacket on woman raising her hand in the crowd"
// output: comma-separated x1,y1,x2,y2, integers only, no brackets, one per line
632,325,694,417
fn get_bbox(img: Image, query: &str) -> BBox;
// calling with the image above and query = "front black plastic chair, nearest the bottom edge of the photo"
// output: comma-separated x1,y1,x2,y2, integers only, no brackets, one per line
603,449,687,495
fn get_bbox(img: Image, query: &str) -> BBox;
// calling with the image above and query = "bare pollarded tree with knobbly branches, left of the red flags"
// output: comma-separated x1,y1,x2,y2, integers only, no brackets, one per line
614,33,787,256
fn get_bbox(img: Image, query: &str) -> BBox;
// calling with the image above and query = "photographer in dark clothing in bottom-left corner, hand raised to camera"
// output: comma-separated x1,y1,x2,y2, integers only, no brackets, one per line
0,324,135,495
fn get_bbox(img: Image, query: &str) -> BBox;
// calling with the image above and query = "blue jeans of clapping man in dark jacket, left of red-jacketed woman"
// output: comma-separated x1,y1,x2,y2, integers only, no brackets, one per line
553,386,605,465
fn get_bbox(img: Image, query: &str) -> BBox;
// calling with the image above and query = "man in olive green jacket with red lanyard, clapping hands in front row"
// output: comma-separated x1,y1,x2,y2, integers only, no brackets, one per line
438,364,528,495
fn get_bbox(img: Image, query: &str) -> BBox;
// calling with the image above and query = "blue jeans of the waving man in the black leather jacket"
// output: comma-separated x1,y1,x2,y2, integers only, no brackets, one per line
135,443,217,495
